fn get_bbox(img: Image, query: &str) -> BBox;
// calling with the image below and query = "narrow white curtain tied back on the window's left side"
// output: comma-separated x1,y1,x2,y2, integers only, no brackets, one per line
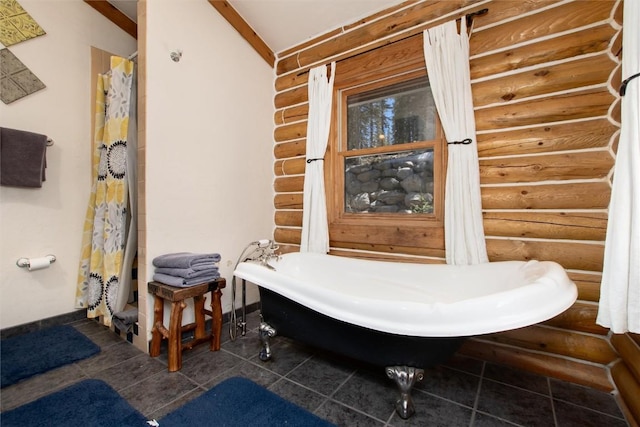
300,62,336,254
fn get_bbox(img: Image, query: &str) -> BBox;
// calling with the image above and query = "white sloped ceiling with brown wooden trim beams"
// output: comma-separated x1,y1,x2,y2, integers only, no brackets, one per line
92,0,402,65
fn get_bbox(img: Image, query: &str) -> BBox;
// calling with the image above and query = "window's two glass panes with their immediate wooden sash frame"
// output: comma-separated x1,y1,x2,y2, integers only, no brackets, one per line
331,72,443,222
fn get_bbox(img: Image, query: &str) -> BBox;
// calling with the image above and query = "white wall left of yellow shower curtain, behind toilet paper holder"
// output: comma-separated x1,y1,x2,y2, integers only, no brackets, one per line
0,0,136,328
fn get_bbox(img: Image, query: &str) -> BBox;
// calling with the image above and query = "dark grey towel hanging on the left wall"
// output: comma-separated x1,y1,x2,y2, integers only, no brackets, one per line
0,128,47,188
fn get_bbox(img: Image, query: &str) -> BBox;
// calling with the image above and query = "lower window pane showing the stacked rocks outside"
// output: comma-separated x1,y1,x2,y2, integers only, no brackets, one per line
344,148,433,214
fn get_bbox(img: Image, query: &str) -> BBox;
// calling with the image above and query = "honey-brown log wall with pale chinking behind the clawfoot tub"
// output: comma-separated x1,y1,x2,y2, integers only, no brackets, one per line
274,0,640,422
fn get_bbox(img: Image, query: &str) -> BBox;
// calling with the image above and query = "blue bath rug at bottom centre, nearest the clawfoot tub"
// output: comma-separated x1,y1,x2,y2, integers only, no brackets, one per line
159,377,333,427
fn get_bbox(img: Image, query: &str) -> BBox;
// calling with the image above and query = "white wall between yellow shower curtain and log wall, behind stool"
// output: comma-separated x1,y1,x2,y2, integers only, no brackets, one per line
140,0,275,333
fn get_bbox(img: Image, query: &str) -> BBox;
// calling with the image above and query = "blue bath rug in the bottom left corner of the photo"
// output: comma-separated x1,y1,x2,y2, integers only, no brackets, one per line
0,380,149,427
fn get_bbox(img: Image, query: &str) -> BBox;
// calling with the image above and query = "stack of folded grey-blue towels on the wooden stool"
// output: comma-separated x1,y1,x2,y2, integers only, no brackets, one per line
153,252,220,287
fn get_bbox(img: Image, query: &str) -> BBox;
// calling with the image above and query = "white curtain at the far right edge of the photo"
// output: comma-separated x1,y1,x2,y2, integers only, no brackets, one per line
596,1,640,333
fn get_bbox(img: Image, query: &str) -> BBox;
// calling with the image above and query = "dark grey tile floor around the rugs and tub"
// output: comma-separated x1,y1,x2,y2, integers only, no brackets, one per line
0,313,628,427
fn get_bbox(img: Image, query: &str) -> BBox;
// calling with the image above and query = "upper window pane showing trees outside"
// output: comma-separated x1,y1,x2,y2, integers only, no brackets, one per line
347,77,436,150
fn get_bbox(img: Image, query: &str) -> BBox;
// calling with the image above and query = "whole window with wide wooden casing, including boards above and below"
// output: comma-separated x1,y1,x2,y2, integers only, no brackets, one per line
325,34,446,259
